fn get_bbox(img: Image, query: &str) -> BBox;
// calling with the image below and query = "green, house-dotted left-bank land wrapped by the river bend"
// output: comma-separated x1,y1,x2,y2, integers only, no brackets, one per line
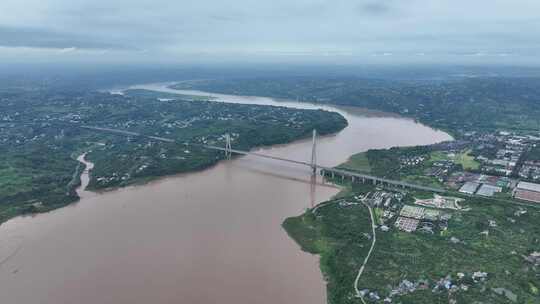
0,89,347,223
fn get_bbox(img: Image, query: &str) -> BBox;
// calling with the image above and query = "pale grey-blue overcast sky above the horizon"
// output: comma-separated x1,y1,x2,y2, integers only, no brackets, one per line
0,0,540,63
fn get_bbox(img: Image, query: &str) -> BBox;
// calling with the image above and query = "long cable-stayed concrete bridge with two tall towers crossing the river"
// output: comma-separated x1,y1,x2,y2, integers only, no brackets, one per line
82,126,446,193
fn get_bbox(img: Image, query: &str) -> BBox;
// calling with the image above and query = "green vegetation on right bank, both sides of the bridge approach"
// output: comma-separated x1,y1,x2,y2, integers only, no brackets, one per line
283,130,540,304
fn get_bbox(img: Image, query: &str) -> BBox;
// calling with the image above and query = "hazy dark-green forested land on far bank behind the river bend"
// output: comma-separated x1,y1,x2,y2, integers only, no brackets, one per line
176,77,540,136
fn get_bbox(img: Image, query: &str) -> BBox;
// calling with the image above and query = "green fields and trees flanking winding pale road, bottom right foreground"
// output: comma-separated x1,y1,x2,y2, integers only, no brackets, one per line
284,197,540,304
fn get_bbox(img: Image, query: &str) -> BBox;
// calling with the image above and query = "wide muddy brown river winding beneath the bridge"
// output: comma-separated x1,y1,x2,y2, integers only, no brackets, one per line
0,84,451,304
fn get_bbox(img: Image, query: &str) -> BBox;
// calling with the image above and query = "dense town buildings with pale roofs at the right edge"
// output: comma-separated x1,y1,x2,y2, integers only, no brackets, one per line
426,131,540,203
